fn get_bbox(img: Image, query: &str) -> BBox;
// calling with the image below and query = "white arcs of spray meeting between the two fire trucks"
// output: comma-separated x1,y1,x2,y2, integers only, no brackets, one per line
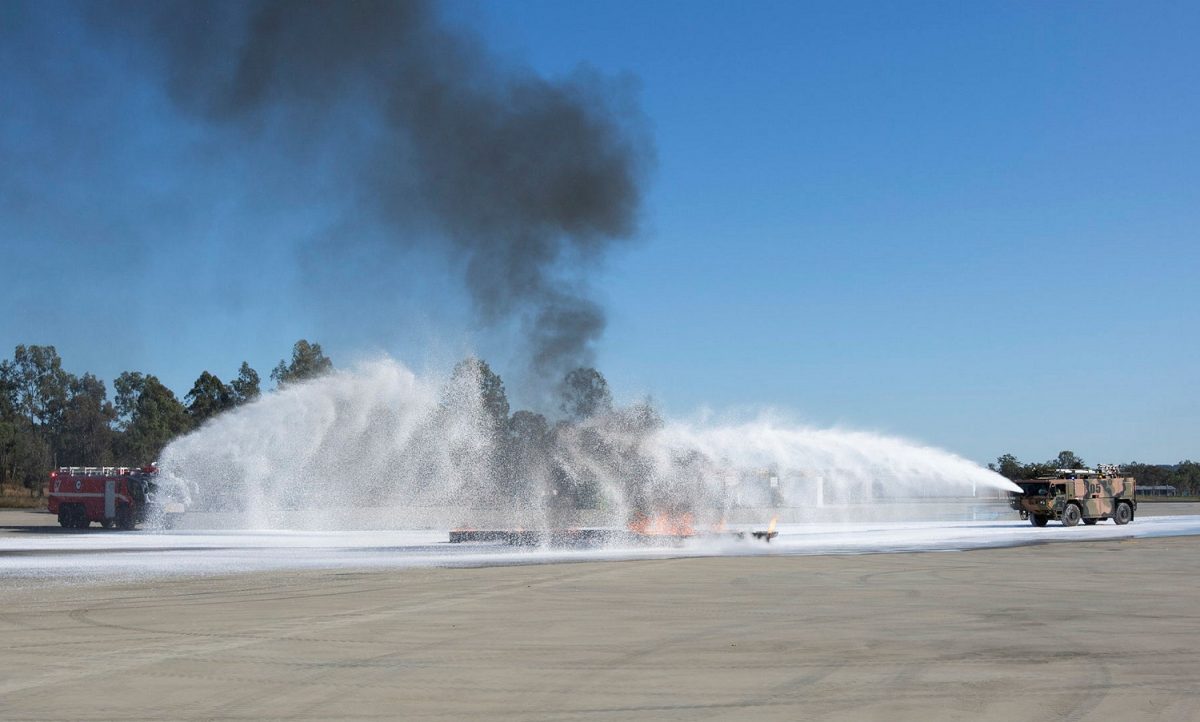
160,360,1013,529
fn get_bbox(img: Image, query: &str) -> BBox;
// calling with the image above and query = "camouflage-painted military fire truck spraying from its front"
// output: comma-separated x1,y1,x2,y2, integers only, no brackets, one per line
1009,464,1138,527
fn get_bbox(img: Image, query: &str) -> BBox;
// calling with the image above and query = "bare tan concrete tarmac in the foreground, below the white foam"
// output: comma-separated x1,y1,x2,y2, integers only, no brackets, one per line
0,537,1200,722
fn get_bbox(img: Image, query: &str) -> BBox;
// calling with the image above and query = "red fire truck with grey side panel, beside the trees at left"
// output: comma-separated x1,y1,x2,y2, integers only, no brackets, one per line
49,464,184,529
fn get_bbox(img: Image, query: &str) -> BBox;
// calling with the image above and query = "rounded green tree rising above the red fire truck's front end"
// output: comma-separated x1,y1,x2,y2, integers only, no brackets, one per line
113,372,192,465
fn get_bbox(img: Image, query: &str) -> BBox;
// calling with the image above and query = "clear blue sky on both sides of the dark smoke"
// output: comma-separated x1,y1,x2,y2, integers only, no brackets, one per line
0,0,1200,462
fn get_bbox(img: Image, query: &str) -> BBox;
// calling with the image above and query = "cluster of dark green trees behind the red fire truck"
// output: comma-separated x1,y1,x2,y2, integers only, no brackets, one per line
0,339,332,492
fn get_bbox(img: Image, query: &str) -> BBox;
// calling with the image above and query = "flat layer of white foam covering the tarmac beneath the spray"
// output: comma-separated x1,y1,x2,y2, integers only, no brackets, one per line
0,506,1200,583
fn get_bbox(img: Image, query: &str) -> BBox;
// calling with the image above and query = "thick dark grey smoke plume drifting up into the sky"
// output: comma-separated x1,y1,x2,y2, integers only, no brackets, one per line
111,0,652,380
